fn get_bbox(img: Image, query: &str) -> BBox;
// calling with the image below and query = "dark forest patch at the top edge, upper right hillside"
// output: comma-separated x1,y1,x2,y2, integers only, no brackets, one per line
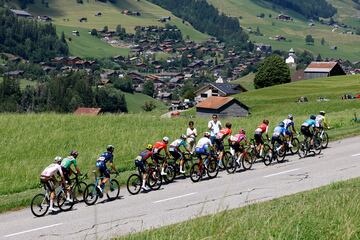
265,0,337,19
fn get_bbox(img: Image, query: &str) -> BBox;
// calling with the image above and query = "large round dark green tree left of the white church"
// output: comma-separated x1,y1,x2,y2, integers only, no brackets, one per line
254,55,291,88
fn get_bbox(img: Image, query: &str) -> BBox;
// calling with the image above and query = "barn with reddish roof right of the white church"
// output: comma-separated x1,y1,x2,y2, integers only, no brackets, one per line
304,62,346,79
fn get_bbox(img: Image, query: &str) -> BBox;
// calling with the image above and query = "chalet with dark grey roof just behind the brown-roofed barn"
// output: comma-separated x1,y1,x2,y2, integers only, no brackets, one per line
195,83,247,102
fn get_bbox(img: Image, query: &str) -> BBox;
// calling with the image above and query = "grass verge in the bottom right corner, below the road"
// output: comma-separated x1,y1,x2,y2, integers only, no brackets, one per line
119,178,360,240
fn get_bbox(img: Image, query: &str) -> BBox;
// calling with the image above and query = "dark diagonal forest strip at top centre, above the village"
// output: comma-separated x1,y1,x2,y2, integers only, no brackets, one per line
151,0,249,48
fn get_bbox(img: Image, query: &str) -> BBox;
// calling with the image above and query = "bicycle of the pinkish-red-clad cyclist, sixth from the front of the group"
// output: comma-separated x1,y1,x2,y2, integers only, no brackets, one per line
224,145,253,174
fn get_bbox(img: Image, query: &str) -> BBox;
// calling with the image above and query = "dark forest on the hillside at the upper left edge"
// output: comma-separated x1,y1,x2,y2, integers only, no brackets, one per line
0,9,69,62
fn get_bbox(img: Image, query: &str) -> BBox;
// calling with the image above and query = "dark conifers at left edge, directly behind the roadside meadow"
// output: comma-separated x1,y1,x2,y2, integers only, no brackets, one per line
0,72,127,112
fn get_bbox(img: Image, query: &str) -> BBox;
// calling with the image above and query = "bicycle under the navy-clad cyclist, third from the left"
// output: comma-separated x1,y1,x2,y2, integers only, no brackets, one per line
84,170,120,206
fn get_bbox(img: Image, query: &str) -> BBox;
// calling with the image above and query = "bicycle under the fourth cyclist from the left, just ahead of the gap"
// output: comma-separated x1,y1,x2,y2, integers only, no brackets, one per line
126,160,162,195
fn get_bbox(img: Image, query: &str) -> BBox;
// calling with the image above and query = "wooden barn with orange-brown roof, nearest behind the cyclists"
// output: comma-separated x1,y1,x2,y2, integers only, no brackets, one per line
196,97,249,117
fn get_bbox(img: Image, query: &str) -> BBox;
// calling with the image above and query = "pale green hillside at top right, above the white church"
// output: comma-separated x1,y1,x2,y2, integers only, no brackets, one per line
209,0,360,61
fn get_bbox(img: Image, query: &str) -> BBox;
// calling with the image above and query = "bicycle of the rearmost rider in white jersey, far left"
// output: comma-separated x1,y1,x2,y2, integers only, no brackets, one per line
30,182,74,217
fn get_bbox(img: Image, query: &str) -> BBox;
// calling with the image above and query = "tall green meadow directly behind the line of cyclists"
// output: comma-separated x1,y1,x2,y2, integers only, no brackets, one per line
0,76,360,212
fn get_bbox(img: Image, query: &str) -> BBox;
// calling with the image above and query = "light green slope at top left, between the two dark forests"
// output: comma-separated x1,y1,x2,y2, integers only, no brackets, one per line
29,0,207,57
